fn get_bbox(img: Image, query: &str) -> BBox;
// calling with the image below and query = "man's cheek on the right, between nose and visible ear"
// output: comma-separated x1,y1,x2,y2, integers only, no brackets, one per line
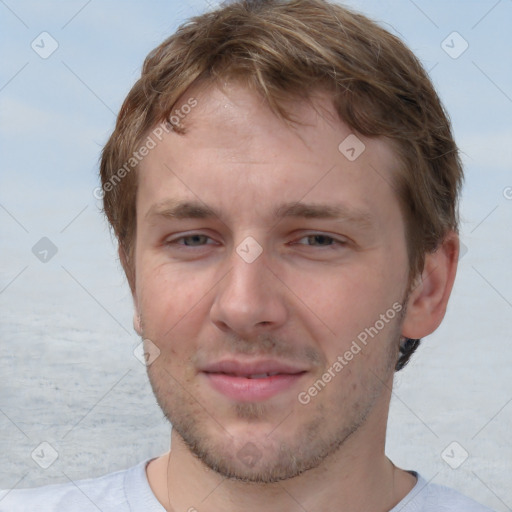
284,258,402,376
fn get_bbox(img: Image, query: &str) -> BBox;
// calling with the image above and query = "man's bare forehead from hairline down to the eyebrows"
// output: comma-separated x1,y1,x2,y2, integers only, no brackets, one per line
138,83,397,226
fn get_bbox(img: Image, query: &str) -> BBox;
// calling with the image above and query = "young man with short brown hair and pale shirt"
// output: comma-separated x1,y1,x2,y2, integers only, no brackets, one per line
0,0,496,512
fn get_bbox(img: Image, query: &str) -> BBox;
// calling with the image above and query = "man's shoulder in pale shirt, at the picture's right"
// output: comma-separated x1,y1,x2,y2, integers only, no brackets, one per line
391,473,493,512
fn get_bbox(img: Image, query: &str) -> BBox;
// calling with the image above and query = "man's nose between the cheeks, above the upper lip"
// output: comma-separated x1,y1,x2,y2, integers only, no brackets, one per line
210,243,288,338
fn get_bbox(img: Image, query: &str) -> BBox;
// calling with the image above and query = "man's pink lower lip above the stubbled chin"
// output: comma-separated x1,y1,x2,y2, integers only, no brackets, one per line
204,372,305,402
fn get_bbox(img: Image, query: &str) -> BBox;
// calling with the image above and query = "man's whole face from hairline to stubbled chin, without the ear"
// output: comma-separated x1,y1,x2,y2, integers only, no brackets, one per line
134,84,408,482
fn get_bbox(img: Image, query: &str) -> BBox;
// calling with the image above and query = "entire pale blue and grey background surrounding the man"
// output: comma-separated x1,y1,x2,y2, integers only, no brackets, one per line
0,0,512,511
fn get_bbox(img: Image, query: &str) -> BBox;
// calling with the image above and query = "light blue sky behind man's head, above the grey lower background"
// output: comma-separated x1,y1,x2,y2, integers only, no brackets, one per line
0,0,512,292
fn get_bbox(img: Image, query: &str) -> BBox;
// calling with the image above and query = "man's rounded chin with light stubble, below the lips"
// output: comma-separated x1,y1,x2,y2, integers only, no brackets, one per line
170,400,357,484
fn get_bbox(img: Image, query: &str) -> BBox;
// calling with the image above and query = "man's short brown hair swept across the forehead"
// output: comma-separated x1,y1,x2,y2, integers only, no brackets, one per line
100,0,463,367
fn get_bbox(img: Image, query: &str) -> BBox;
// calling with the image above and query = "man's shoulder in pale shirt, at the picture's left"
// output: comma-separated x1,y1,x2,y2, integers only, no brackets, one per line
0,466,134,512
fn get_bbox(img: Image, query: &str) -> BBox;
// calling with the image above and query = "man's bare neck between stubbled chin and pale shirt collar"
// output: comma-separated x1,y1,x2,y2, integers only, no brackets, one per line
147,428,416,512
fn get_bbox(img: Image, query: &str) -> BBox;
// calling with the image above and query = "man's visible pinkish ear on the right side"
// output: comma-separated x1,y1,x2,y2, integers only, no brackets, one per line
402,231,459,339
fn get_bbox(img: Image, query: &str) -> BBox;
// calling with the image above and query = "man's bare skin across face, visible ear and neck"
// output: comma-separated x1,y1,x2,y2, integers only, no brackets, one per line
125,83,458,512
